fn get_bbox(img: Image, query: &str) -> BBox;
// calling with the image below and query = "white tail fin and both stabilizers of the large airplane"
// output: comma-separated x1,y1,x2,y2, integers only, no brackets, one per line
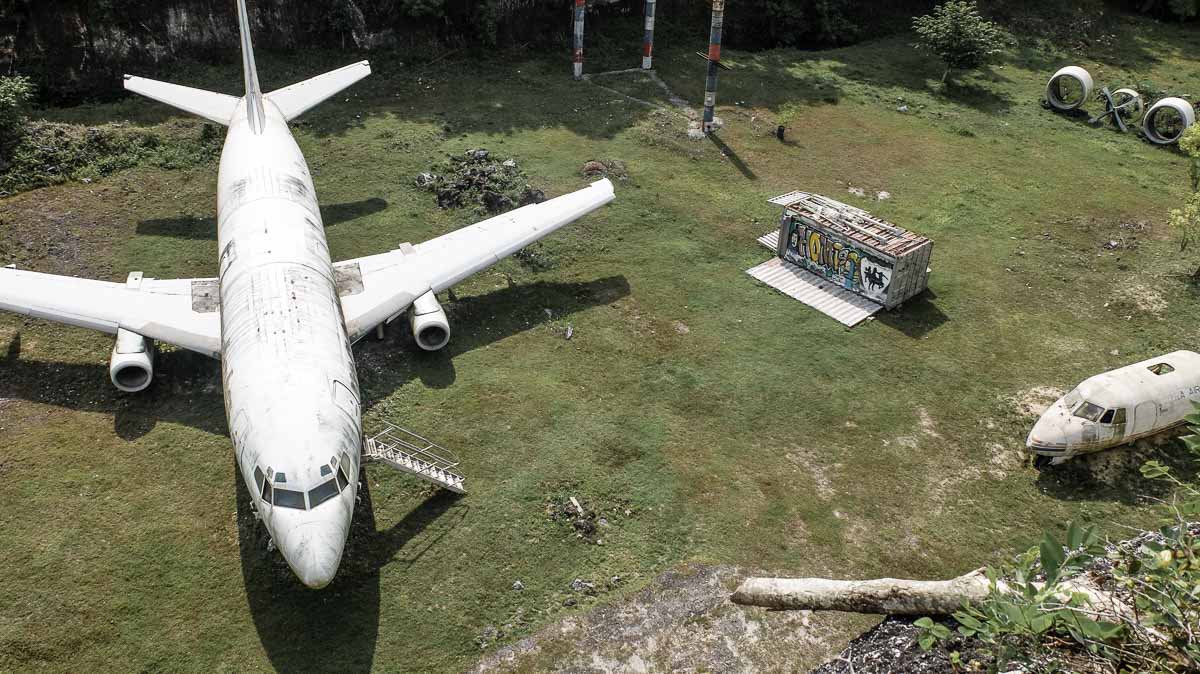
125,0,371,128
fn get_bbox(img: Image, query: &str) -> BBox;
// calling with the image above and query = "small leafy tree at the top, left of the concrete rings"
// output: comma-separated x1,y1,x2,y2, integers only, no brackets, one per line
912,0,1007,83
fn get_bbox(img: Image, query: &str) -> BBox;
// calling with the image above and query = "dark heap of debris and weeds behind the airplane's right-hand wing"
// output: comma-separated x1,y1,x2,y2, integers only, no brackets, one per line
414,149,546,215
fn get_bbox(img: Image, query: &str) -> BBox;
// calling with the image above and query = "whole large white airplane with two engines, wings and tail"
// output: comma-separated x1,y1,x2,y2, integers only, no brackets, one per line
0,0,613,588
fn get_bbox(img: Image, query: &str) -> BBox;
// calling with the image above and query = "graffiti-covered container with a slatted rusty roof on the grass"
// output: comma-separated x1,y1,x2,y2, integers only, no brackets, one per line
770,192,934,309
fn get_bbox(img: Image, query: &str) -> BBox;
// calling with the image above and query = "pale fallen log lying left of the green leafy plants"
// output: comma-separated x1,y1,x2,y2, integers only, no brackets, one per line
731,568,988,615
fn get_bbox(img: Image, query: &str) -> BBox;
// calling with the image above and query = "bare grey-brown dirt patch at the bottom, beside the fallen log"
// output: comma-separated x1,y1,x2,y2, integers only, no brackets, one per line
472,565,840,674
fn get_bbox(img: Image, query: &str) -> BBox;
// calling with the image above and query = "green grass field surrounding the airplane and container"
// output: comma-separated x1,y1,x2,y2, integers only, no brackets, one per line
0,11,1200,672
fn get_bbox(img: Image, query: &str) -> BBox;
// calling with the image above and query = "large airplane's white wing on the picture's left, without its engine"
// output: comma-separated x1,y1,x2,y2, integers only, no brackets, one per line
0,267,221,359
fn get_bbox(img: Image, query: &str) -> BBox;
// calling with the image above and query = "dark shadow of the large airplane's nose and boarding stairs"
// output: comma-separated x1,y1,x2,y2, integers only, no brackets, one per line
233,464,469,673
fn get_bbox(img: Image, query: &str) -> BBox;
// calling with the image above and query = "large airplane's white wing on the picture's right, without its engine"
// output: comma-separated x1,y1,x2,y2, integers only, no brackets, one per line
334,180,613,342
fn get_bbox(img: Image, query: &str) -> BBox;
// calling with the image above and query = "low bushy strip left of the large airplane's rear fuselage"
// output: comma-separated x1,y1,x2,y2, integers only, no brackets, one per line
0,121,221,192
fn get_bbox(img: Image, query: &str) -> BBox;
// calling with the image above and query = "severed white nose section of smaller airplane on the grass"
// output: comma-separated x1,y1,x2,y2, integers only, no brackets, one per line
1025,351,1200,465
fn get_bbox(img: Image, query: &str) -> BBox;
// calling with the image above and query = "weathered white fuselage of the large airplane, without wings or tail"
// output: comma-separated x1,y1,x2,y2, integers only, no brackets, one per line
217,101,362,588
